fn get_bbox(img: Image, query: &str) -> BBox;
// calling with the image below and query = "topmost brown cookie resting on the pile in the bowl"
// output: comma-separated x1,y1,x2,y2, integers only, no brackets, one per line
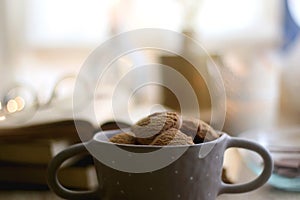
131,112,182,144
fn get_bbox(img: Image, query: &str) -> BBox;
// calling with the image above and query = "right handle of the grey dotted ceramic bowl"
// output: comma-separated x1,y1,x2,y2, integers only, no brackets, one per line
219,137,273,194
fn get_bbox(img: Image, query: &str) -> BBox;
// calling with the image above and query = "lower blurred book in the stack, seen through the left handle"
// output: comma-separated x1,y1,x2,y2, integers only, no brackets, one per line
0,156,97,189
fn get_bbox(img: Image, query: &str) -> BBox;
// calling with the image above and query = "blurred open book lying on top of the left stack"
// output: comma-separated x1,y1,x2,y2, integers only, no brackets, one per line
0,120,95,165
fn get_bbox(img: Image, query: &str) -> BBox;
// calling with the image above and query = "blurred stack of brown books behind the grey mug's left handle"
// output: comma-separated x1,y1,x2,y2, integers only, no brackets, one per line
0,120,96,189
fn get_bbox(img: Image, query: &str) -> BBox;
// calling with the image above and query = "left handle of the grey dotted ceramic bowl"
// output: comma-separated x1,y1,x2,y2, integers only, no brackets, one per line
47,143,99,199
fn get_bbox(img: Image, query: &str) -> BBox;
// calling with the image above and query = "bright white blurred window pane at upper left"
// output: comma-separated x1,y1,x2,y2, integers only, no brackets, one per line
26,0,111,47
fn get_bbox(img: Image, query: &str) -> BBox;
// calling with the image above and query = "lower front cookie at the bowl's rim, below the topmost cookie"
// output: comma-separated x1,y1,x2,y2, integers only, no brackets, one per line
150,128,194,146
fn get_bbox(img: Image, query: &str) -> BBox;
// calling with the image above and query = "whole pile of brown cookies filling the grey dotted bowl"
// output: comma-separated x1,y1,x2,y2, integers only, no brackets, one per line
110,112,220,146
